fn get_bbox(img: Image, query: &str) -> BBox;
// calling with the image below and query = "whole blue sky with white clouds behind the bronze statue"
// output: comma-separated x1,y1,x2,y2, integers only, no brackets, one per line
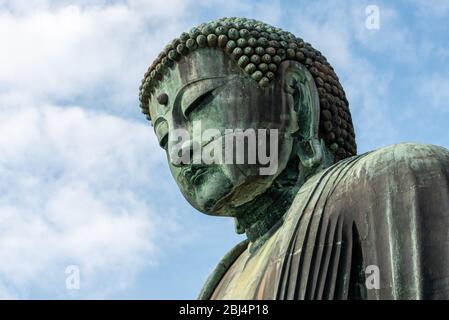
0,0,449,299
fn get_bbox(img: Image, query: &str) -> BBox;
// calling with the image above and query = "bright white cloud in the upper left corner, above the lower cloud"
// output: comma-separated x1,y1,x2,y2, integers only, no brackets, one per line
0,0,197,113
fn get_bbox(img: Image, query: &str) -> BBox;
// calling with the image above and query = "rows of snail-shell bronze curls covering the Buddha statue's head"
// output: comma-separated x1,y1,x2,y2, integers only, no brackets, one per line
139,18,357,161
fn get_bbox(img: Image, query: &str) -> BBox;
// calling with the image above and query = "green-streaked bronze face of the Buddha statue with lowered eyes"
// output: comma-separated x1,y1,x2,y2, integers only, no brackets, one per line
149,48,297,216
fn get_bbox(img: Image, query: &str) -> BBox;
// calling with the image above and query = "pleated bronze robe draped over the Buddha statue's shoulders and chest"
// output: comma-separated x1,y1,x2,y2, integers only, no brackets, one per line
199,143,449,300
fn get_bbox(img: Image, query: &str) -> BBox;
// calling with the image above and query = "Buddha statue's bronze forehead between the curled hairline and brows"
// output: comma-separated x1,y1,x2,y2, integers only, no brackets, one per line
149,48,243,120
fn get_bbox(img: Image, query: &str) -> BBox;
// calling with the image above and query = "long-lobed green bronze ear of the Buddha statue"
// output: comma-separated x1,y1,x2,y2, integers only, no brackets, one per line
279,61,324,168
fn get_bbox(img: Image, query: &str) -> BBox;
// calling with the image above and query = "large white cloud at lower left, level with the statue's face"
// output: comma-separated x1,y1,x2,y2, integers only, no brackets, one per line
0,92,176,298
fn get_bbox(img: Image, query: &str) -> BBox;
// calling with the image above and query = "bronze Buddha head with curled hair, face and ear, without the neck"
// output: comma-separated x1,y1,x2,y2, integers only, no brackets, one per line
140,18,356,216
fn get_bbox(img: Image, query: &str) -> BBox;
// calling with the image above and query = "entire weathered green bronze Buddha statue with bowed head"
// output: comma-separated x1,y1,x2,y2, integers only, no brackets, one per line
140,18,449,299
